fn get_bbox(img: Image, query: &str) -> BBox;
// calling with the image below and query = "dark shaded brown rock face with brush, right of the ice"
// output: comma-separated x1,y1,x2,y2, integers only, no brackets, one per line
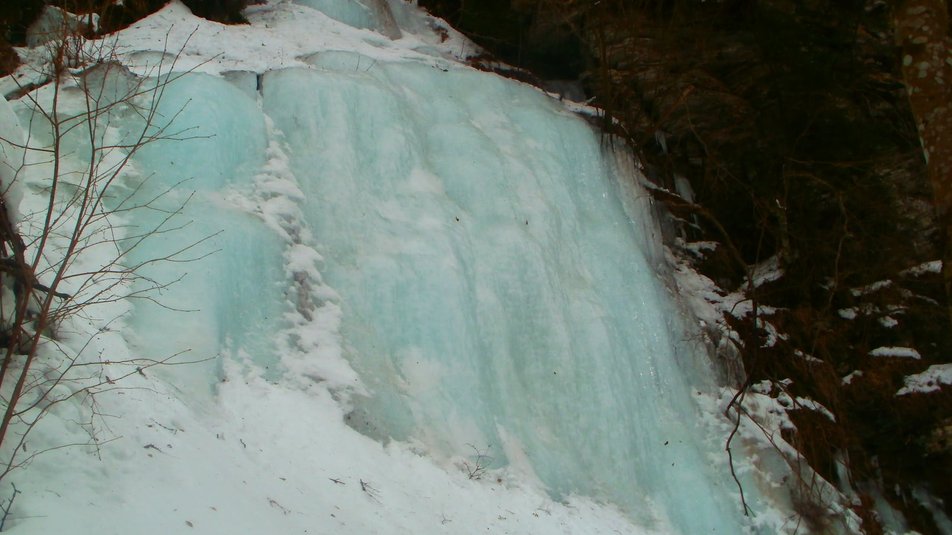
420,0,952,533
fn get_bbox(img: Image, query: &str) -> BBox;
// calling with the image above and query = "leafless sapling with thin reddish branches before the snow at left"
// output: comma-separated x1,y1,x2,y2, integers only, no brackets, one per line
0,12,210,490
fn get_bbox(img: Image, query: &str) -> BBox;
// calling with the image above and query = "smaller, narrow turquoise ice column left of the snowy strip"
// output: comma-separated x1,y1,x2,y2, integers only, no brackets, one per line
115,73,286,394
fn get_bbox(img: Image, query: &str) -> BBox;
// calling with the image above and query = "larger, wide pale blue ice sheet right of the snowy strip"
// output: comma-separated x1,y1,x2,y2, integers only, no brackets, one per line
255,56,737,533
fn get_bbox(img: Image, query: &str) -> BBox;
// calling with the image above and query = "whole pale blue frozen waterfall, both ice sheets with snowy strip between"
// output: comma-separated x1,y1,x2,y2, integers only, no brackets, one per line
0,0,768,534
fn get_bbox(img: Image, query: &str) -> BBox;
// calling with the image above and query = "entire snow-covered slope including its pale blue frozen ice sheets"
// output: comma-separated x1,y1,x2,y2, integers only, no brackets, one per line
0,0,804,534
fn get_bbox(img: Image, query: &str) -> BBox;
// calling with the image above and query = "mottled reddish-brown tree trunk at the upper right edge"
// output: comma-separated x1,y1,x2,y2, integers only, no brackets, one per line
893,0,952,330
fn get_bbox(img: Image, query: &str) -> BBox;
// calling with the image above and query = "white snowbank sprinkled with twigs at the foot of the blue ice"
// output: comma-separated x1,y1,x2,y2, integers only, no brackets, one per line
13,365,652,533
